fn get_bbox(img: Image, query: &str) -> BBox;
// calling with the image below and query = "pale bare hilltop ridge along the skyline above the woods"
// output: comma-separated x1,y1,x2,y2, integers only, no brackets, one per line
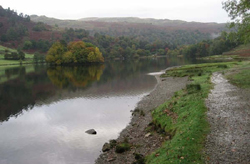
30,15,226,36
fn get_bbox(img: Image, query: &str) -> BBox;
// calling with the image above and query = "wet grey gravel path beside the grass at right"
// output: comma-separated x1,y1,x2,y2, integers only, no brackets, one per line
206,73,250,164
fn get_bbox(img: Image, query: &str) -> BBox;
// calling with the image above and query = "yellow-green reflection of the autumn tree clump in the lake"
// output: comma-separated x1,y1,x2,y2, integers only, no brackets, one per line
47,65,104,88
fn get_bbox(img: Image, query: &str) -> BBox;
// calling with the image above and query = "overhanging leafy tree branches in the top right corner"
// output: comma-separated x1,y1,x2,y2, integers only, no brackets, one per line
223,0,250,43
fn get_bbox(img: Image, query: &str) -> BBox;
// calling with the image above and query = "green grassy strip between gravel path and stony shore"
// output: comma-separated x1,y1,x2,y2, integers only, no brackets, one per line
147,62,241,164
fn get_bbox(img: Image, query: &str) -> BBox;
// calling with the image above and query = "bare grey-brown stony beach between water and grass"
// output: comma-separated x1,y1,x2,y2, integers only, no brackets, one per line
96,75,188,164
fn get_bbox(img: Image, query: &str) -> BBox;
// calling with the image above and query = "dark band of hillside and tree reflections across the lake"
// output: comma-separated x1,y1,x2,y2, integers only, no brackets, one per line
0,58,192,122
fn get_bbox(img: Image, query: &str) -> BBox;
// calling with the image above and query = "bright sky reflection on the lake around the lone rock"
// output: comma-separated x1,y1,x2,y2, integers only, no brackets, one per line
0,95,145,164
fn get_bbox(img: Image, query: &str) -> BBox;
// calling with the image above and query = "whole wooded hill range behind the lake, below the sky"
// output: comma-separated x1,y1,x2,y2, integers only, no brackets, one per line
0,6,229,59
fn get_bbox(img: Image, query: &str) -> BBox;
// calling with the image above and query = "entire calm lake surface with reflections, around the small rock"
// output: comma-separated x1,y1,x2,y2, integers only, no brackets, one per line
0,58,194,164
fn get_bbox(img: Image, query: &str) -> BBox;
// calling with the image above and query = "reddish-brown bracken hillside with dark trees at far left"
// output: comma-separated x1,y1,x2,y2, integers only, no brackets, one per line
0,6,62,52
